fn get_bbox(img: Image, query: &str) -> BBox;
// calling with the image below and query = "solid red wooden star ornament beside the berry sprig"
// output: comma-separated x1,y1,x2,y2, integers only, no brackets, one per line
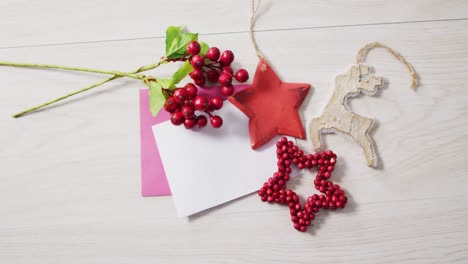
228,59,310,149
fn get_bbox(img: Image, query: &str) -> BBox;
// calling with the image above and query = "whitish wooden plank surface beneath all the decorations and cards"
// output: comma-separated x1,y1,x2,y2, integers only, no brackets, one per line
0,0,468,264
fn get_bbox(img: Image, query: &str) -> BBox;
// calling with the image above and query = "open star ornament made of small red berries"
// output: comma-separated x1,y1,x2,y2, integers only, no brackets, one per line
258,137,348,232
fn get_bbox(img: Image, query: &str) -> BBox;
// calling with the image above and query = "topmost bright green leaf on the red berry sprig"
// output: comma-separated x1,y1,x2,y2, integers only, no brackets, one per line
166,26,198,59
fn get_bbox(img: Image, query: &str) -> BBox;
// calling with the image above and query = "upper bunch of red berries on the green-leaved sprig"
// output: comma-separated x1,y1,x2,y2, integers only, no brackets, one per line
187,41,249,96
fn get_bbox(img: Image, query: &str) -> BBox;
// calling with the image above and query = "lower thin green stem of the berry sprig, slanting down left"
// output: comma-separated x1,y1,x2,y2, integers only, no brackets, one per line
10,59,166,118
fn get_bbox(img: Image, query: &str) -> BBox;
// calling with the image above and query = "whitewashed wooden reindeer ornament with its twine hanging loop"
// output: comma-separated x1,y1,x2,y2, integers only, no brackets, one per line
310,42,418,167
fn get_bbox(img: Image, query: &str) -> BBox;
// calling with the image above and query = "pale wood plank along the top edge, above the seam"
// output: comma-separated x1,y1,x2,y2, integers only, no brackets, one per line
0,0,468,48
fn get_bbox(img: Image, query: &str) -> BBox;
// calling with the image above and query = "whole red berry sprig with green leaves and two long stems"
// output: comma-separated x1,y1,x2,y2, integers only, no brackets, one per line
0,26,249,124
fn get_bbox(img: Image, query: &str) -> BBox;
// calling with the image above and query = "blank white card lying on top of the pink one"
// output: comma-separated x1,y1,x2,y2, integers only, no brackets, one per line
153,101,294,216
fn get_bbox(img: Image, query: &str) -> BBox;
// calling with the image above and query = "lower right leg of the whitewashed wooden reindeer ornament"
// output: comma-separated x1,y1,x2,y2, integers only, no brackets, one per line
350,114,377,167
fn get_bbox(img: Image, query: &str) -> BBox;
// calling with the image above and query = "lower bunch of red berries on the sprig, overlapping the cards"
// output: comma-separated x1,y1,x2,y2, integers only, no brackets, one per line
164,83,223,129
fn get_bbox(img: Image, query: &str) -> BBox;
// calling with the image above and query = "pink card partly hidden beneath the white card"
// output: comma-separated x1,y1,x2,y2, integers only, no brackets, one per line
140,85,247,196
